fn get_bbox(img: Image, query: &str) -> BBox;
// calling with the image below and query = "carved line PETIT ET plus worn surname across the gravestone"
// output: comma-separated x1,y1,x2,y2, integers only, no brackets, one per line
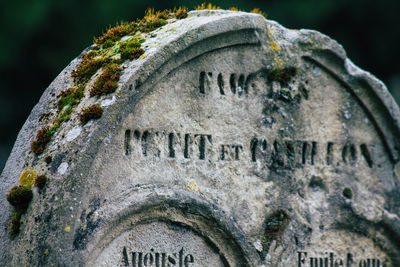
124,129,374,168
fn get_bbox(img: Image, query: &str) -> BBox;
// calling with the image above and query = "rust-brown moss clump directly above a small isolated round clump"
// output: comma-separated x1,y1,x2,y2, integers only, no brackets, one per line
90,63,121,96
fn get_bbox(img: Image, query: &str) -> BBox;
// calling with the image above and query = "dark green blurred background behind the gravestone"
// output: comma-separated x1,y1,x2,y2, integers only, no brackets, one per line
0,0,400,171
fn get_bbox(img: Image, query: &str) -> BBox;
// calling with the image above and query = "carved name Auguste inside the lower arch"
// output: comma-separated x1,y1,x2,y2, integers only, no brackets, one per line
122,247,195,267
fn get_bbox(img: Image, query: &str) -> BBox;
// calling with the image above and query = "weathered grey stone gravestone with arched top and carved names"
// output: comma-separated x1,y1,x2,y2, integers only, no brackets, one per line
0,10,400,267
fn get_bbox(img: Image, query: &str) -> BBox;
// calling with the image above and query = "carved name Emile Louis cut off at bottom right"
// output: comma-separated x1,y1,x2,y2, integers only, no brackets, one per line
297,251,389,267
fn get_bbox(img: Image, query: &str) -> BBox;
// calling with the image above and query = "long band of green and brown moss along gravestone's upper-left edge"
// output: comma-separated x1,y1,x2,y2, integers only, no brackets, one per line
31,7,198,155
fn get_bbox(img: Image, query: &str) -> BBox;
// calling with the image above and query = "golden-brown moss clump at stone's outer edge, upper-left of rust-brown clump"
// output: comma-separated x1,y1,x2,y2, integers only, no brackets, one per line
71,56,109,85
